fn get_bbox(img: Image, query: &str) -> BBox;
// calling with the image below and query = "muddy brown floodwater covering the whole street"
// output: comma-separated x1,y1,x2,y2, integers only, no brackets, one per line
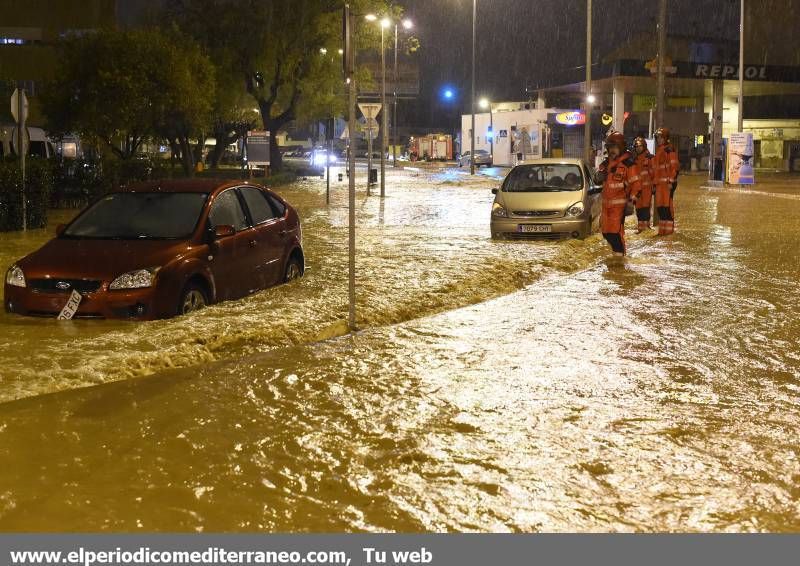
0,169,800,532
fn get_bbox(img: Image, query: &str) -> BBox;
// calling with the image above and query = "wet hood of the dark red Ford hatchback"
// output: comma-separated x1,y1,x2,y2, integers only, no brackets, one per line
18,238,196,281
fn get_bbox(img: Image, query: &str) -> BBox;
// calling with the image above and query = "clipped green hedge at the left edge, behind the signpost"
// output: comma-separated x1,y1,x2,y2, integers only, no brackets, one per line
0,158,53,232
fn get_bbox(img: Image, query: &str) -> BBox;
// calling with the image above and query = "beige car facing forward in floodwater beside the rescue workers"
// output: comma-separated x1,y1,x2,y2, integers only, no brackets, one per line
491,158,601,239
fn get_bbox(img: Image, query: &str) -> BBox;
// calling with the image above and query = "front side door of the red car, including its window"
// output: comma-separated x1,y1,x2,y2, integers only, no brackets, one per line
208,189,259,300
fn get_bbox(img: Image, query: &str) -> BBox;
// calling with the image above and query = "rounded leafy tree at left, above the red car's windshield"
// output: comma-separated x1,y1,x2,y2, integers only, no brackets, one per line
42,29,215,172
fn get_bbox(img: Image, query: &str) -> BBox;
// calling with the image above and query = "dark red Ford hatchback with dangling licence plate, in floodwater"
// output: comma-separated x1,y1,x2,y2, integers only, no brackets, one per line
4,180,305,320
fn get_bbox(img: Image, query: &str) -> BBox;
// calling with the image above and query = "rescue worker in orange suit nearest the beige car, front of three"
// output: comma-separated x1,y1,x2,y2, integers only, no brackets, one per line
595,132,642,256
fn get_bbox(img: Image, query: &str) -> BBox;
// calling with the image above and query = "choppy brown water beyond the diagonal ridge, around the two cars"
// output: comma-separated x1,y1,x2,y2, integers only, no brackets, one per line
0,169,600,401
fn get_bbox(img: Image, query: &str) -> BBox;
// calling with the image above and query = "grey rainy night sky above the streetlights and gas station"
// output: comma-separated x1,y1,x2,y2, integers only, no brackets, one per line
404,0,739,111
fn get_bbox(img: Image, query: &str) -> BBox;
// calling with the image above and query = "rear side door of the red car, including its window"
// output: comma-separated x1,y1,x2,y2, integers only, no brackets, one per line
239,187,286,287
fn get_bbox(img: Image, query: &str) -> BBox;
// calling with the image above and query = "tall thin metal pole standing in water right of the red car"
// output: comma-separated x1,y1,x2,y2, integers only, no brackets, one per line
344,4,356,332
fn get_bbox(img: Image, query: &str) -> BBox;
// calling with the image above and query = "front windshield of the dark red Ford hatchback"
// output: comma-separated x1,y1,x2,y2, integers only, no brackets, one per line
62,193,208,240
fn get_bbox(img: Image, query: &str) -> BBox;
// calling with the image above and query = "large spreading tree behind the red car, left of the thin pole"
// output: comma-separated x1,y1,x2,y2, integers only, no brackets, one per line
166,0,397,170
